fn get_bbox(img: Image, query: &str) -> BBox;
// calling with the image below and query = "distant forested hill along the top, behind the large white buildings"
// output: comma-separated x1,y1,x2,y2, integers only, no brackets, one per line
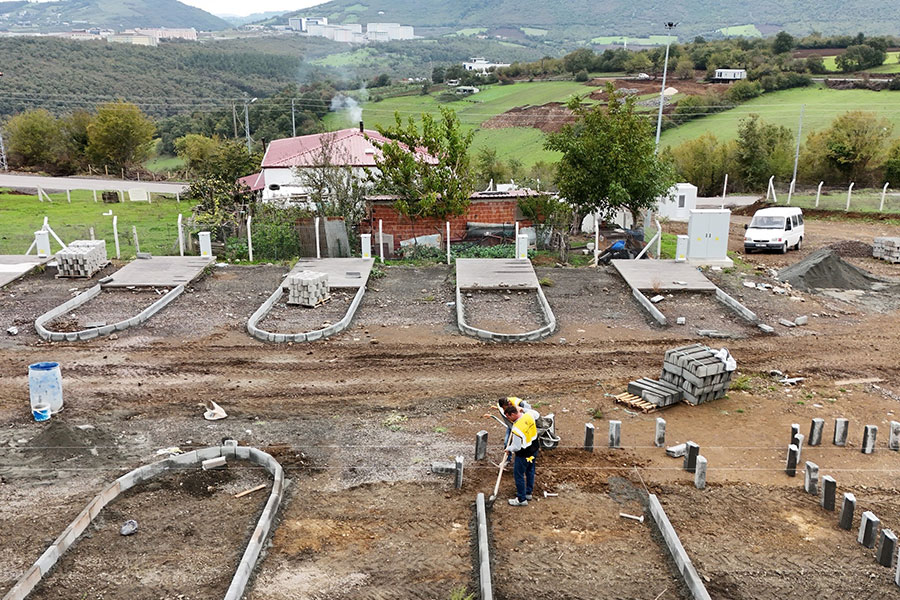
289,0,900,39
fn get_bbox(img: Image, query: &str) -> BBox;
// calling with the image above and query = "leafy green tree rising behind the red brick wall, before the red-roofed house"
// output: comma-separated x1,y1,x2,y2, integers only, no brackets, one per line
372,107,475,237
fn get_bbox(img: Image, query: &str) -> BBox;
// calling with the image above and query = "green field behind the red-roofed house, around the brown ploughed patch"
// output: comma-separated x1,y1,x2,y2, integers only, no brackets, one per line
325,81,597,166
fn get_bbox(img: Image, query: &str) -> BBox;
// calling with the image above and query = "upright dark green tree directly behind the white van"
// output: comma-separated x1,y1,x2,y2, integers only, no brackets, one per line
737,114,794,190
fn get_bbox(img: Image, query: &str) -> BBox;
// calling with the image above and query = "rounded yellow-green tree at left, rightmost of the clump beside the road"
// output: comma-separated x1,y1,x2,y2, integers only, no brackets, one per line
87,101,156,167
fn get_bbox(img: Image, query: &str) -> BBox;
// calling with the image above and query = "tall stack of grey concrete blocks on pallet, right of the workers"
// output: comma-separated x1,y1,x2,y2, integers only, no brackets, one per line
660,344,732,405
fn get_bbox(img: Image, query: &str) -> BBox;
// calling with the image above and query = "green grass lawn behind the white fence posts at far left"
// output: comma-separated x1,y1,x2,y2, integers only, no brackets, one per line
0,190,192,259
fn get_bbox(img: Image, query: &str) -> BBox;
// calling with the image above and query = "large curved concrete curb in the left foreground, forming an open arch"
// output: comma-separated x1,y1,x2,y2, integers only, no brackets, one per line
3,446,284,600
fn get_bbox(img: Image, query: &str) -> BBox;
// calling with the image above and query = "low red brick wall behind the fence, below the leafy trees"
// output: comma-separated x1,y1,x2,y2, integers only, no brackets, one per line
360,200,531,250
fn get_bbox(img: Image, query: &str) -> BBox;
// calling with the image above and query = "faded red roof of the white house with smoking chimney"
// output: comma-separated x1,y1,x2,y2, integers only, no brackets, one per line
262,129,428,169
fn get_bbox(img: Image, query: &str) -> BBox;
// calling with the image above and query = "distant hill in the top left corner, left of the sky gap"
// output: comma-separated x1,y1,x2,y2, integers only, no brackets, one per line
0,0,231,31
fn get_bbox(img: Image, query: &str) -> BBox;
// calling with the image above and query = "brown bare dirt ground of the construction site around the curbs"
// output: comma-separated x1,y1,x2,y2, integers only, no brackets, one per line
0,217,900,600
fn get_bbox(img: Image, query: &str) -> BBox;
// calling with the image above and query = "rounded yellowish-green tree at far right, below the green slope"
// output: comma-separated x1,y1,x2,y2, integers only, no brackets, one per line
825,110,893,183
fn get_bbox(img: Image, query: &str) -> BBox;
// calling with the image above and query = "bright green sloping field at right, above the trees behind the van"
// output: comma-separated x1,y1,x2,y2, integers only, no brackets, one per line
660,85,900,146
